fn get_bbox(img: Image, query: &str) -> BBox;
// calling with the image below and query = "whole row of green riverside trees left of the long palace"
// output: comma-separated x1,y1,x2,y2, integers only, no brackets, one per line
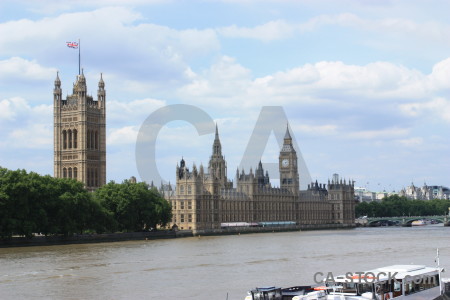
0,167,172,240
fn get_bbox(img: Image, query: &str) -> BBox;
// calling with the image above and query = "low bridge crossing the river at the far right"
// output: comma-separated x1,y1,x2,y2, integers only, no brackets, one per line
356,215,449,227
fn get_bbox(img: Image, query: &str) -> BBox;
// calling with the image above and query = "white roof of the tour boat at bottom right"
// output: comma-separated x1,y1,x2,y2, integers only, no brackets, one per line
334,265,439,282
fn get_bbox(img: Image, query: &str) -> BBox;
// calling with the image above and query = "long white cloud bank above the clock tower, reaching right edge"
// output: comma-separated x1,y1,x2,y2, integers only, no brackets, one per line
178,56,450,107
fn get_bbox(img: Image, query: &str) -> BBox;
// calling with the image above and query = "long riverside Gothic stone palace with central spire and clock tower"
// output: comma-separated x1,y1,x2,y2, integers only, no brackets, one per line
168,127,355,231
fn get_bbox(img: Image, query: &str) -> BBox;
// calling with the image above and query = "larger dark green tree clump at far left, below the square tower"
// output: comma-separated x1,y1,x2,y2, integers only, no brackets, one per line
0,164,115,238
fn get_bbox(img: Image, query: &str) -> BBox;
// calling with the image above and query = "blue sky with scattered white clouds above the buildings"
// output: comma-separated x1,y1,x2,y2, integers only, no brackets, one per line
0,0,450,191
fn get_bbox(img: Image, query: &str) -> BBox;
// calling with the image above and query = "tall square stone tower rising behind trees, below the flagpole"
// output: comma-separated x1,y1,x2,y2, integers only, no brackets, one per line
53,73,106,191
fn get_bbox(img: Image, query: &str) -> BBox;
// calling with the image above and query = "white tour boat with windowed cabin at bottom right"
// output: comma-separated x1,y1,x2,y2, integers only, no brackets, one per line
320,265,441,300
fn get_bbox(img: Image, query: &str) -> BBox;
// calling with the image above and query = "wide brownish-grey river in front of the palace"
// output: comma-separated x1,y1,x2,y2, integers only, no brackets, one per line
0,225,450,300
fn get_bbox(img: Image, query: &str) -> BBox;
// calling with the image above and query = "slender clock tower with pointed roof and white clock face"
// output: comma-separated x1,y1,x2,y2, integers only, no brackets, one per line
279,127,300,196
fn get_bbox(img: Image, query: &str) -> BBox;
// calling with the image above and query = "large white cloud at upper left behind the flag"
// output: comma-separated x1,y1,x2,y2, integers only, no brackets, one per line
0,7,219,85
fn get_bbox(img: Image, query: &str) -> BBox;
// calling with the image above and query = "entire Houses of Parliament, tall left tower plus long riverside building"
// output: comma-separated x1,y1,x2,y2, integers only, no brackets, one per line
53,72,355,233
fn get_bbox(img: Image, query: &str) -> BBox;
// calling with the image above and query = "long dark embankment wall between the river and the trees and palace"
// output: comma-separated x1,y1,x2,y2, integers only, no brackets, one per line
0,224,355,248
